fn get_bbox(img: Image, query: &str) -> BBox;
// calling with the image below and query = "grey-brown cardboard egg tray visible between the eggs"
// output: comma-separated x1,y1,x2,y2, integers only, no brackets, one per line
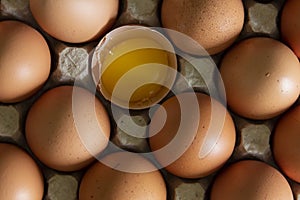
0,0,300,200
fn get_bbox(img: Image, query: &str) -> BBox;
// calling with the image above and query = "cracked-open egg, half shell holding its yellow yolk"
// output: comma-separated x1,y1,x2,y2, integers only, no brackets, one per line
93,26,177,109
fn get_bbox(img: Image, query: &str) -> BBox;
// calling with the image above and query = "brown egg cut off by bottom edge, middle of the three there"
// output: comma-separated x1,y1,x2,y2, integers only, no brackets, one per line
79,152,167,200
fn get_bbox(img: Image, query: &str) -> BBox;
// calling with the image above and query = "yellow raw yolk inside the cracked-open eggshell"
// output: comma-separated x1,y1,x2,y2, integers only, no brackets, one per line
101,39,169,105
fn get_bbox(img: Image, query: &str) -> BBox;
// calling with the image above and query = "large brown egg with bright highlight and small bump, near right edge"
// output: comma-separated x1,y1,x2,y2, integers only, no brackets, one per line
220,37,300,119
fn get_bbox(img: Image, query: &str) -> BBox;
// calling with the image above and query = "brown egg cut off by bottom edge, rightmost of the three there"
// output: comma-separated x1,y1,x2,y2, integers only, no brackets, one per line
210,160,294,200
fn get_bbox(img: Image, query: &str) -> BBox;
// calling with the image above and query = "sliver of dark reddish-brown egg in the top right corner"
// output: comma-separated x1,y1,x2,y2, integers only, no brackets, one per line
280,0,300,58
